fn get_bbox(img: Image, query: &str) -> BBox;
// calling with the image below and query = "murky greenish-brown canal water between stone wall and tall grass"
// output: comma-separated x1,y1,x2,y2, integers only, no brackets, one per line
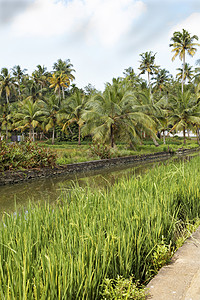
0,156,197,215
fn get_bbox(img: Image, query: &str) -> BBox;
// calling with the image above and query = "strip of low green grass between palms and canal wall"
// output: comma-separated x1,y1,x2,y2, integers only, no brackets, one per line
39,137,198,164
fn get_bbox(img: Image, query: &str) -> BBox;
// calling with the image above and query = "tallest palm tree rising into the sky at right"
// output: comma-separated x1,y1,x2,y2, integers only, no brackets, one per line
169,29,200,93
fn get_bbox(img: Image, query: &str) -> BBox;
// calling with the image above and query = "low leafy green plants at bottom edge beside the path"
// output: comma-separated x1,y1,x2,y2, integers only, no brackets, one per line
102,275,146,300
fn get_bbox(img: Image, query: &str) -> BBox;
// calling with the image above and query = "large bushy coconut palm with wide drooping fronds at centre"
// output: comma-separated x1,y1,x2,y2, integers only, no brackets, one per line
82,79,154,147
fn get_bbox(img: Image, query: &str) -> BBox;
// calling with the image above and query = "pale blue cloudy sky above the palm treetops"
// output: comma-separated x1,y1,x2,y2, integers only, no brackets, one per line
0,0,200,90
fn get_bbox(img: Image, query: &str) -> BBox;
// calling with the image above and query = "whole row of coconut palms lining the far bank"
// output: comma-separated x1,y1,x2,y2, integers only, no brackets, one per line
0,29,200,147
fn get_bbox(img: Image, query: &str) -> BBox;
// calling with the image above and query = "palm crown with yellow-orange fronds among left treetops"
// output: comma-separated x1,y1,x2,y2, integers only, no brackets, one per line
49,72,70,101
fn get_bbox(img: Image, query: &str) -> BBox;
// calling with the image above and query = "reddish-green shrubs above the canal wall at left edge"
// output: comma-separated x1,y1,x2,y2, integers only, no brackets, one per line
0,141,56,171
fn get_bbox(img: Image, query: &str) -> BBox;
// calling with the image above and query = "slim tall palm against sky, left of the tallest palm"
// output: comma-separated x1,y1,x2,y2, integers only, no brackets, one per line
139,51,159,89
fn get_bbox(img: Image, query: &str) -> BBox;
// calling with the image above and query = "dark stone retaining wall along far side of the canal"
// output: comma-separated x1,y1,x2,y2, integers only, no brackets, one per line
0,147,200,186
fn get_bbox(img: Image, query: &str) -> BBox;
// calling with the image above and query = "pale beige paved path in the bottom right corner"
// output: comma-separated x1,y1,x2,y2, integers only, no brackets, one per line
147,227,200,300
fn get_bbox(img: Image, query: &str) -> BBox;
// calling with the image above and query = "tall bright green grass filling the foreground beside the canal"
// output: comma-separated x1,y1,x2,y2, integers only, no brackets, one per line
0,158,200,300
